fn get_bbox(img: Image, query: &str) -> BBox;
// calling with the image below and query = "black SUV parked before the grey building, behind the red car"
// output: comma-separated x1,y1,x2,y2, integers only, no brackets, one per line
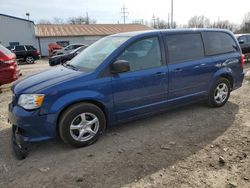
7,45,40,64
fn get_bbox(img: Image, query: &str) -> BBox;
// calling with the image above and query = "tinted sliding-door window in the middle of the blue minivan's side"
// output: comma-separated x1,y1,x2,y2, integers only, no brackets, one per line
166,33,204,63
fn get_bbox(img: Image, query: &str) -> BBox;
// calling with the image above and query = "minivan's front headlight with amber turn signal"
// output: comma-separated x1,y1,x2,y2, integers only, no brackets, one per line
18,94,44,110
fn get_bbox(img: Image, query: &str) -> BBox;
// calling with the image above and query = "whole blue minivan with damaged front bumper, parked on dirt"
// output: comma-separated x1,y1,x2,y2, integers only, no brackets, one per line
9,29,244,157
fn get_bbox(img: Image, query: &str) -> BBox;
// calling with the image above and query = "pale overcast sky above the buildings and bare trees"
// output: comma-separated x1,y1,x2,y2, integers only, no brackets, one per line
0,0,250,24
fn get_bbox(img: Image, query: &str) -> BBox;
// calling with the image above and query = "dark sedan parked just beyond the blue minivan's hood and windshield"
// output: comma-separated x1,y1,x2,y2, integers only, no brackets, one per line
49,46,87,66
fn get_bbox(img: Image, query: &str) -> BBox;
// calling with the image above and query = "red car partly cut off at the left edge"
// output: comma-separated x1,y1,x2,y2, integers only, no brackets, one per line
0,44,20,85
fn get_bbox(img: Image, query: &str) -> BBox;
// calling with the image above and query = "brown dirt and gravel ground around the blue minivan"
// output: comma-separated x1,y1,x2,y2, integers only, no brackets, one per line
0,60,250,188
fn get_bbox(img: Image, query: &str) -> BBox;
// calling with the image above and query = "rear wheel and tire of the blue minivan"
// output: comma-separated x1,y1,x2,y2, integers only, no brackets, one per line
207,77,231,107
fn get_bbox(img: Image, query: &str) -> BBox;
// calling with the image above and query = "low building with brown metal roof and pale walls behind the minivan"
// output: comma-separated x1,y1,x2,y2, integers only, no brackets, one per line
36,24,151,56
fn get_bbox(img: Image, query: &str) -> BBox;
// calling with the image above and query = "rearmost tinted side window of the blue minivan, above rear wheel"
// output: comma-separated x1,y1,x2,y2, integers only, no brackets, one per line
203,32,238,55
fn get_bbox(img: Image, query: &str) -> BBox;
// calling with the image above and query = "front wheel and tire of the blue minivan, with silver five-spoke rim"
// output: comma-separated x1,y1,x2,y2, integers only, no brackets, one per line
59,103,106,147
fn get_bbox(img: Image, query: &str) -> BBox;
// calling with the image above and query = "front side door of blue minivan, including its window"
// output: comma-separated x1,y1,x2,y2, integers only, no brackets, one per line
112,36,168,120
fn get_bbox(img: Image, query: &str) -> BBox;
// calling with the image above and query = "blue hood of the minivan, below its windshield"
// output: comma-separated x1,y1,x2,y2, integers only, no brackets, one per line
12,66,86,95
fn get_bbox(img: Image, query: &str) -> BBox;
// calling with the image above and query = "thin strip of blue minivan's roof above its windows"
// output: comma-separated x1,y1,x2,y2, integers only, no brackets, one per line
111,28,235,37
